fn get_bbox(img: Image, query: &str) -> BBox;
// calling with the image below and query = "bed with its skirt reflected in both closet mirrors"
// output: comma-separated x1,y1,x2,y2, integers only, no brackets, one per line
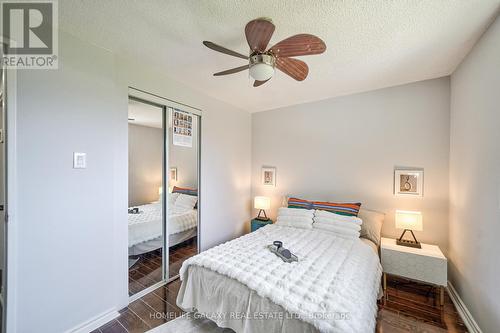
128,202,198,255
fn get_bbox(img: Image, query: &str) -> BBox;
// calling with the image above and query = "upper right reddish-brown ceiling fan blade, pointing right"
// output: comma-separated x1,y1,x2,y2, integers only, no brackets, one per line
270,34,326,57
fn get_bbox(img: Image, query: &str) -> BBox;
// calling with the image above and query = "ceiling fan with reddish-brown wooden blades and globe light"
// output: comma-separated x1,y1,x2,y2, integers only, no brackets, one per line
203,18,326,87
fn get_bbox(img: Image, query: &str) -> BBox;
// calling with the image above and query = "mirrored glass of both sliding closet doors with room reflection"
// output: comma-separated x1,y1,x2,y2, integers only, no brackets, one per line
128,100,198,295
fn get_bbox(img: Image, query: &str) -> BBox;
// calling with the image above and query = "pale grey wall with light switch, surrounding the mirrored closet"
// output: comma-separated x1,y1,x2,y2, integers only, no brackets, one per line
9,32,251,333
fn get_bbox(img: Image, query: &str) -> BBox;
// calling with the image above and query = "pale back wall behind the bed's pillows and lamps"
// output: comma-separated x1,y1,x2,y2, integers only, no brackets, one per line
252,78,450,251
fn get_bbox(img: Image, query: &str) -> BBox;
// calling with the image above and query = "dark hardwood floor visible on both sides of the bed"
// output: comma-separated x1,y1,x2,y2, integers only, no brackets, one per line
98,277,467,333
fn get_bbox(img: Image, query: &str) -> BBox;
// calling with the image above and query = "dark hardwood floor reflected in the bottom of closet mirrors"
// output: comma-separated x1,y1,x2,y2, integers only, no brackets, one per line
128,237,197,295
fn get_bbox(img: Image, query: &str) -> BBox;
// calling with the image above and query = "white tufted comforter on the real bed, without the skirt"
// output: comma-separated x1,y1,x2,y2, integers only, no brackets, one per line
180,225,382,333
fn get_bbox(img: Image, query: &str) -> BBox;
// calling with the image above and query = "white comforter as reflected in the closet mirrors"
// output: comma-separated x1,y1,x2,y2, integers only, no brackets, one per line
128,203,198,247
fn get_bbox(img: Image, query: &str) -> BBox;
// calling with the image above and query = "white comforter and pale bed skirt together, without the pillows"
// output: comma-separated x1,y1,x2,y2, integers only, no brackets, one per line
177,225,382,333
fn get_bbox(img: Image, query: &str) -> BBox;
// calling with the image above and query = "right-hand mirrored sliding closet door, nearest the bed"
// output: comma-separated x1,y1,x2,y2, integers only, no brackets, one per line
167,107,200,279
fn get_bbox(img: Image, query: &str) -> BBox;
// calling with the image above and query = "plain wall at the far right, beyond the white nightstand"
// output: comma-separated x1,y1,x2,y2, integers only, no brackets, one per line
449,13,500,332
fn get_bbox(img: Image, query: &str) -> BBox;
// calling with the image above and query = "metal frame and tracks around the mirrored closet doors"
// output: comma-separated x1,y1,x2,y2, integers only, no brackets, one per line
127,86,202,303
